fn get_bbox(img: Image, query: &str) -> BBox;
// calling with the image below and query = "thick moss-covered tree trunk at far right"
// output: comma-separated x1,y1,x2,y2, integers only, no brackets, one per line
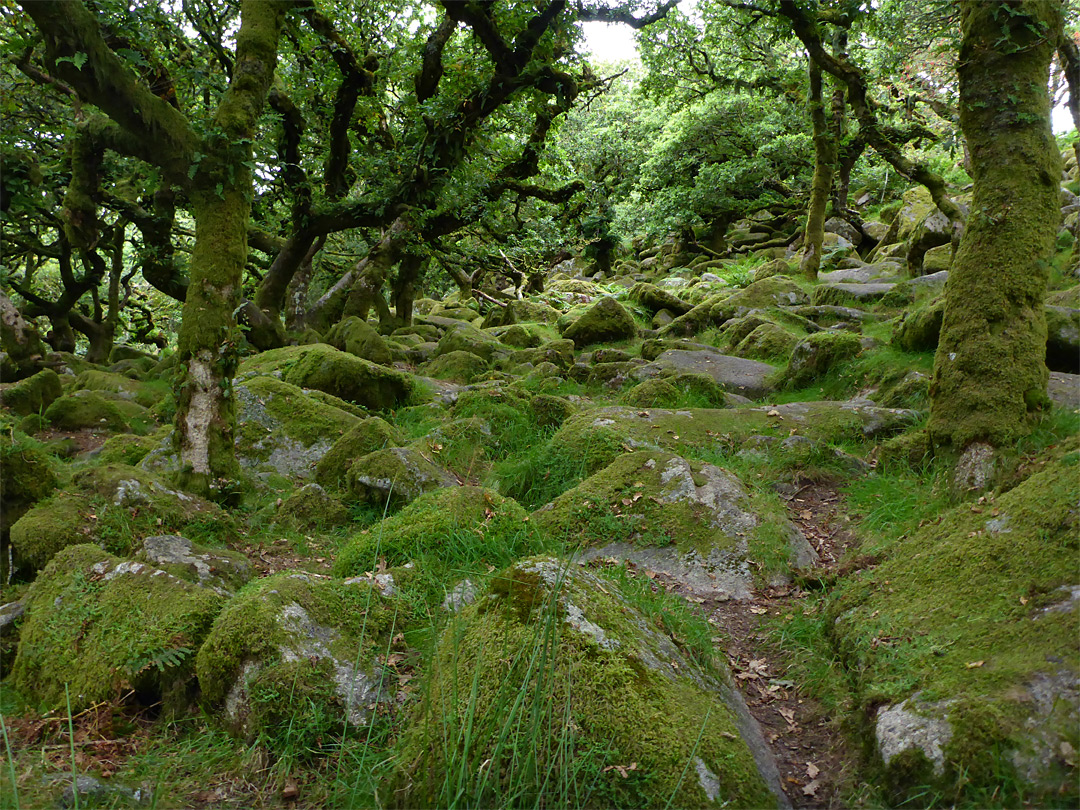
929,0,1062,449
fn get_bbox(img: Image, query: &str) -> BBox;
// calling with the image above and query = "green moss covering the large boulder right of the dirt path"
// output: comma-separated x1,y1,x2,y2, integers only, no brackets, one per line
828,455,1080,805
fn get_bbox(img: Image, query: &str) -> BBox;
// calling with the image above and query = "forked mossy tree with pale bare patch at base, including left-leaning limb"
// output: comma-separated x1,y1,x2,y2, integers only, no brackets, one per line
21,0,289,494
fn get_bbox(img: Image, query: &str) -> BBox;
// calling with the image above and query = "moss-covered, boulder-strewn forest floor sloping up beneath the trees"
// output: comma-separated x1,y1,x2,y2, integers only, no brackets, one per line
0,219,1080,808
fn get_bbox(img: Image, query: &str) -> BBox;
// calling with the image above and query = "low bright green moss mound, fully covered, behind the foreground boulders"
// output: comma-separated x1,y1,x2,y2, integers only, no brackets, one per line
334,486,530,577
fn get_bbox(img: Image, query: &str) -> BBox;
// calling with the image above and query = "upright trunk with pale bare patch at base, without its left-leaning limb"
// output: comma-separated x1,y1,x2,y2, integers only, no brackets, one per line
174,0,285,494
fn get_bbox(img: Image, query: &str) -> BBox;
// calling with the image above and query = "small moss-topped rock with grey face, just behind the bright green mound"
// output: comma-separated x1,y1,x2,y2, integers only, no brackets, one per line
346,447,459,507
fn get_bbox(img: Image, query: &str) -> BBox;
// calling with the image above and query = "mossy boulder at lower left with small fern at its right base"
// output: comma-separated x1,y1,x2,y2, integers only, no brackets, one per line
12,545,224,712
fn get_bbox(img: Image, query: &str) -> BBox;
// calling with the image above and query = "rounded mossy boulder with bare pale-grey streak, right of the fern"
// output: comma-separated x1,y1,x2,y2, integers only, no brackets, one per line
197,573,399,753
